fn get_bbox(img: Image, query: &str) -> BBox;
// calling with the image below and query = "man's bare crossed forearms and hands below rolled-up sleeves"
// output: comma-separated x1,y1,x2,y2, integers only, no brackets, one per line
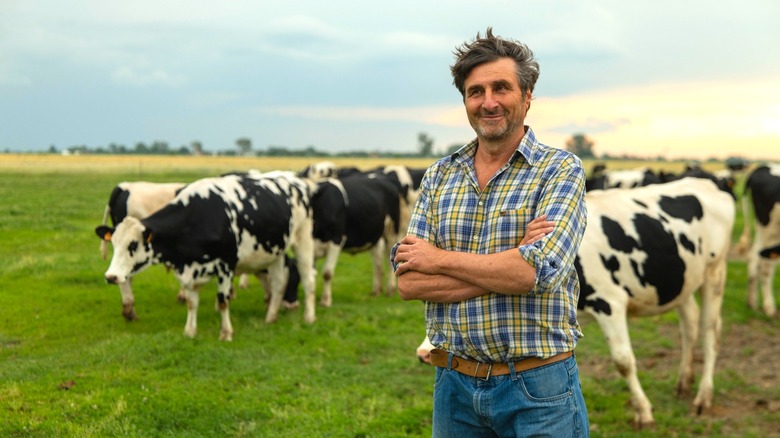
395,215,554,303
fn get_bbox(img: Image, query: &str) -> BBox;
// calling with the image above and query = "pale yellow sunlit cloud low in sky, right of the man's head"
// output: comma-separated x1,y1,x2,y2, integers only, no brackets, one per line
528,76,780,157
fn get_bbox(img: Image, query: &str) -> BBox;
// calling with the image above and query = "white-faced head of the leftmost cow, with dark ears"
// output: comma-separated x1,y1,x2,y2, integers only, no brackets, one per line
95,216,154,284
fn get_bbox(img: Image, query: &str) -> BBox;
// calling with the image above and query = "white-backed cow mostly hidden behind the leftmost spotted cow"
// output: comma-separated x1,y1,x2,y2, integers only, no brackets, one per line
100,181,184,321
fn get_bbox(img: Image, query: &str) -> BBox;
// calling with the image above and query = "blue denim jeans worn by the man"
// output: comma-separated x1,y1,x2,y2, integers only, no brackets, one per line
433,354,590,438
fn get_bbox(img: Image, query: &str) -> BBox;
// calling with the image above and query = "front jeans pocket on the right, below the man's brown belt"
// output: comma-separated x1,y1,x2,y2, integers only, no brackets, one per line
517,361,573,403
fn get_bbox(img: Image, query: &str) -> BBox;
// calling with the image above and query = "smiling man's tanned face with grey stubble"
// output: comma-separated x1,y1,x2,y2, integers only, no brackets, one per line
464,58,531,141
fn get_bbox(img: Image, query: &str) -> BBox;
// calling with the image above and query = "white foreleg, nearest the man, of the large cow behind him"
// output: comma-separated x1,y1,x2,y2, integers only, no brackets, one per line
594,304,655,429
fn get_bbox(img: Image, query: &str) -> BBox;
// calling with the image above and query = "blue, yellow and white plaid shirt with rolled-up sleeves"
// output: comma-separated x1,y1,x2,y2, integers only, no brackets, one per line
391,127,586,362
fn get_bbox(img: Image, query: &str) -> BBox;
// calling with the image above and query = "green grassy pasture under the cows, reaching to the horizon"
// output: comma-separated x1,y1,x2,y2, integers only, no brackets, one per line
0,155,780,437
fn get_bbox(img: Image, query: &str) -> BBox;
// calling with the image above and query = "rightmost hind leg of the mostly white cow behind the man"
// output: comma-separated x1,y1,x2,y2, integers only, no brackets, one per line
693,260,727,414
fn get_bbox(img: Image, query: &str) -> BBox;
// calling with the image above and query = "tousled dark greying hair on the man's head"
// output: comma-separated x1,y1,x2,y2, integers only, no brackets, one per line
450,27,539,98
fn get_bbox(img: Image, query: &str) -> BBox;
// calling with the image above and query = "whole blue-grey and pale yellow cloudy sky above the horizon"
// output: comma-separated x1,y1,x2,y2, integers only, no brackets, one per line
0,0,780,161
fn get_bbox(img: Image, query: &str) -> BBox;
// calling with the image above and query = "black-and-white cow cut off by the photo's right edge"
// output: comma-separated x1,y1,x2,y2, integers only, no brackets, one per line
738,164,780,316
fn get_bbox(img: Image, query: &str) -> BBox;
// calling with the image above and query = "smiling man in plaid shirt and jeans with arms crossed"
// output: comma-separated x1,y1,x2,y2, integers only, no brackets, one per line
391,28,589,437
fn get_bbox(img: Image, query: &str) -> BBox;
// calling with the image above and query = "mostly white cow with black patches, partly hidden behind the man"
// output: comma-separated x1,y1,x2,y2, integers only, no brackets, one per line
417,178,735,428
